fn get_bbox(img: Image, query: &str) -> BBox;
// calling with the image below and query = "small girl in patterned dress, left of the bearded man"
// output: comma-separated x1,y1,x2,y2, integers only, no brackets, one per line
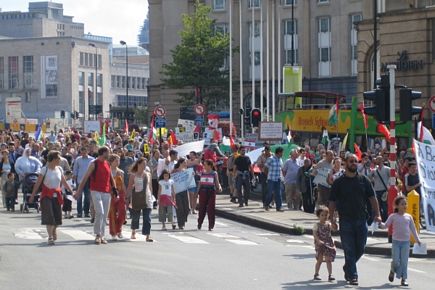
313,206,336,282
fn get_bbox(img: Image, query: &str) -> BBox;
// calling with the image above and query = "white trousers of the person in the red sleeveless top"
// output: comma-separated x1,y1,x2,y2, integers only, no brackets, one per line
91,191,112,237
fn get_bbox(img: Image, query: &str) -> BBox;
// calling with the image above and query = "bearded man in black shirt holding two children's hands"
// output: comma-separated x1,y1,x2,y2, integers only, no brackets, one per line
329,154,381,285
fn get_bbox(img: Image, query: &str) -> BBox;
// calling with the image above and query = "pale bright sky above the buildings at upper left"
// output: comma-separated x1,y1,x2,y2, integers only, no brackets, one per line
0,0,148,45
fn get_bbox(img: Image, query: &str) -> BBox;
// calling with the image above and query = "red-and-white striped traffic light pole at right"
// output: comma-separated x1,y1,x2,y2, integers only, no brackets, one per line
387,65,398,241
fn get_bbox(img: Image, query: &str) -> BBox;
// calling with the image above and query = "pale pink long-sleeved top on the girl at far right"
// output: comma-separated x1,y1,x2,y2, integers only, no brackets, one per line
382,213,418,242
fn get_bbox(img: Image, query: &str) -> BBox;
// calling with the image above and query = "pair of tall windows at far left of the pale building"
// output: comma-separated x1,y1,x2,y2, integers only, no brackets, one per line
0,55,34,89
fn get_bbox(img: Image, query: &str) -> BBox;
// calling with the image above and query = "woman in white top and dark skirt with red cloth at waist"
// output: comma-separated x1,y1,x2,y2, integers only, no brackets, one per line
29,151,72,245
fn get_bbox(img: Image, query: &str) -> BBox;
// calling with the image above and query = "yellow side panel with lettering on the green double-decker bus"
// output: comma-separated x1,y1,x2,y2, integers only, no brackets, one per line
284,110,350,134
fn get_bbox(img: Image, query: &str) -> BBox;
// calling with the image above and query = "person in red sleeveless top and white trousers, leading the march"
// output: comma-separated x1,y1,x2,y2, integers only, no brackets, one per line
75,146,115,245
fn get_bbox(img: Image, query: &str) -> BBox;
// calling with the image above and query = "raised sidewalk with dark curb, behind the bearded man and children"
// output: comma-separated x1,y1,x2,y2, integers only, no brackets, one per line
216,194,435,258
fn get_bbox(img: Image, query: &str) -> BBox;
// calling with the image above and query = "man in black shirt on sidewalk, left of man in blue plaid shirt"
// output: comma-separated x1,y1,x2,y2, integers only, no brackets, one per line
233,147,252,207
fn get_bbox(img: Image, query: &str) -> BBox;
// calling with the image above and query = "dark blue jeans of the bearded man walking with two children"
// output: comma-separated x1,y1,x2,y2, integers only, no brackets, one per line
340,219,368,279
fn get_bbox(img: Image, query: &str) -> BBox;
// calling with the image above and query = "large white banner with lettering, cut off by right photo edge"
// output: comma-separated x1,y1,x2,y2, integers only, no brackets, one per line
414,139,435,232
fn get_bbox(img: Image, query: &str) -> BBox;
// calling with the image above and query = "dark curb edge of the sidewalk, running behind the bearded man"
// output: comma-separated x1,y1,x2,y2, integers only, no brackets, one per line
215,208,435,258
